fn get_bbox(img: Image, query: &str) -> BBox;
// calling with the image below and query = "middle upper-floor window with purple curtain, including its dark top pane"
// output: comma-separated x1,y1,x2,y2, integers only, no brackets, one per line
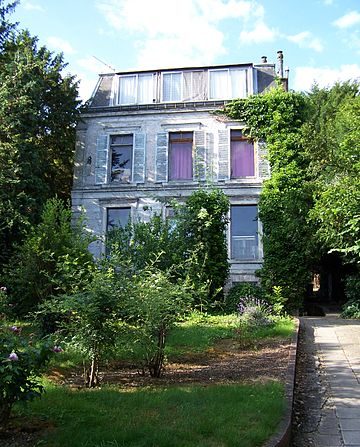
169,132,193,180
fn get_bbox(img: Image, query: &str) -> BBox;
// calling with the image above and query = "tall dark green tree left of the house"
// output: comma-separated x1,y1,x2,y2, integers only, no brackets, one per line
0,28,80,268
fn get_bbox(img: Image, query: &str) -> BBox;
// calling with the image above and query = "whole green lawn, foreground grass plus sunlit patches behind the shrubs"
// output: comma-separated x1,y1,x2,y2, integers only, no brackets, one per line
10,315,294,447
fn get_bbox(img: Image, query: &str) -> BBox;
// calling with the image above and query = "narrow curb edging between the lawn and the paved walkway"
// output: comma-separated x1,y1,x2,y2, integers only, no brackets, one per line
263,318,300,447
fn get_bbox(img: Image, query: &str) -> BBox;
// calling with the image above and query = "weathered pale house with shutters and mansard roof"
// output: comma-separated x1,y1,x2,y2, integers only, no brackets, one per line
72,51,287,282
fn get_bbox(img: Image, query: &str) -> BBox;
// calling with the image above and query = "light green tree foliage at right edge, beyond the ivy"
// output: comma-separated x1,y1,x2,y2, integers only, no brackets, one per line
304,90,360,263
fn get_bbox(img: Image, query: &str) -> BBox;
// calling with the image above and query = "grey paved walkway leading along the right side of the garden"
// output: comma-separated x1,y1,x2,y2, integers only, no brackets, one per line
301,314,360,447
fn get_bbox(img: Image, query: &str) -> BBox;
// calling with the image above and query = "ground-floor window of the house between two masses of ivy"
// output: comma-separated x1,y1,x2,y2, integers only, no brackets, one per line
230,205,259,261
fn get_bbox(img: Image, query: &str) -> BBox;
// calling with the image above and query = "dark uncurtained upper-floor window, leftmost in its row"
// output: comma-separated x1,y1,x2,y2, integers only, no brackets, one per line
110,134,133,183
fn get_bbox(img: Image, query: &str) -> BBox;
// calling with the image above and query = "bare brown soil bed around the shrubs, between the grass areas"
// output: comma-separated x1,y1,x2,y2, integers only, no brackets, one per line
0,339,291,447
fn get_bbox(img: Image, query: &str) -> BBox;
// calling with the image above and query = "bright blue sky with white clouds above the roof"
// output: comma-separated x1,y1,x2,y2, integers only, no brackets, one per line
11,0,360,100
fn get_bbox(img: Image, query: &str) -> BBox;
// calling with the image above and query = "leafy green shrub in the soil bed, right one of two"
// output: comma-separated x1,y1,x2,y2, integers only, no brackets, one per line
126,268,192,377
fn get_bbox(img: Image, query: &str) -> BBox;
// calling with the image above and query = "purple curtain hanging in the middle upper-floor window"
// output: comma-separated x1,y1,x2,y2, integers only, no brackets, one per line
169,142,192,180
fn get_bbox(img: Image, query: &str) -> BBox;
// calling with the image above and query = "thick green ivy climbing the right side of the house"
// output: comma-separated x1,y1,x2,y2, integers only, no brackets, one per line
225,87,316,307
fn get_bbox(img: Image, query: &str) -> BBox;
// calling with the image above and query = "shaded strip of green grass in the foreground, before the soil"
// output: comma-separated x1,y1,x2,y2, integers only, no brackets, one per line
19,382,284,447
